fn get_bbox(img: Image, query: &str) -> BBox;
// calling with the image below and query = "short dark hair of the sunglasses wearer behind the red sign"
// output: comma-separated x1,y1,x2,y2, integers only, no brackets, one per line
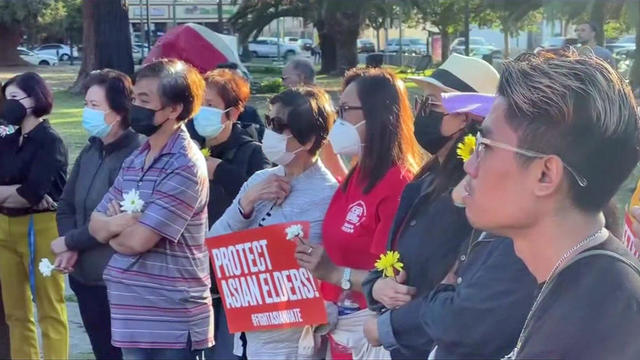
269,86,336,156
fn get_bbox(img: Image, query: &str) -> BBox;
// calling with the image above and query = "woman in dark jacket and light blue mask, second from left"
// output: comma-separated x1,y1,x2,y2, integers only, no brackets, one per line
51,69,142,360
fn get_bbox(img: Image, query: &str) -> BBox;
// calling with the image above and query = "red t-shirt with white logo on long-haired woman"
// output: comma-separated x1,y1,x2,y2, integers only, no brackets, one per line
320,166,412,309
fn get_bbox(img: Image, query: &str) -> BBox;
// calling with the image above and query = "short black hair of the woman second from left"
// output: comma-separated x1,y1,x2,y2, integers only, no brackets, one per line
83,69,133,129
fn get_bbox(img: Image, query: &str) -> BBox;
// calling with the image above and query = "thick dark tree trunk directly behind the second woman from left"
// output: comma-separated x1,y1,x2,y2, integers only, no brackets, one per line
70,0,133,93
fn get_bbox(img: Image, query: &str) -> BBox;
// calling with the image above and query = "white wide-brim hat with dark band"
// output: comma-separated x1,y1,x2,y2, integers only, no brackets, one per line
407,54,500,94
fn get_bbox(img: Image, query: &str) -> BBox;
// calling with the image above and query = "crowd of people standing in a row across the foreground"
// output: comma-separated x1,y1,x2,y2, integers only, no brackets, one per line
0,40,640,360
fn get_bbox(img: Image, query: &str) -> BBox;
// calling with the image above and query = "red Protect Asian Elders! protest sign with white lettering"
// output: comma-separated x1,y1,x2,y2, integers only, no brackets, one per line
207,221,327,333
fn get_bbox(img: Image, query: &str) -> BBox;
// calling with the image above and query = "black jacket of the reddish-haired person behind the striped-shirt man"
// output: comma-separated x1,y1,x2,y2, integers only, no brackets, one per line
187,121,271,226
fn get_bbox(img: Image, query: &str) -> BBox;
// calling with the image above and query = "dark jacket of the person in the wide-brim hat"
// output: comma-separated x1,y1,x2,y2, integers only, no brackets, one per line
363,169,471,311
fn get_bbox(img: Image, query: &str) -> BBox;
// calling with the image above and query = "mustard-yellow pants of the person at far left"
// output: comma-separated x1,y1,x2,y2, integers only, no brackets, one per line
0,212,69,360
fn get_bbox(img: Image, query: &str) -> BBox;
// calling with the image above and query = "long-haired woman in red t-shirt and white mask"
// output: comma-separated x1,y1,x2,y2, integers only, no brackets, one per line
296,69,422,359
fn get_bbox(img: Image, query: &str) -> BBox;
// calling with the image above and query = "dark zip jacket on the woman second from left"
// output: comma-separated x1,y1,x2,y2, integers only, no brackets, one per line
56,130,142,285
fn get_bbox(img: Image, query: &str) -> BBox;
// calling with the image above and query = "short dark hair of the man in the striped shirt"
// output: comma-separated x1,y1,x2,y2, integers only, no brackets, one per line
134,59,205,121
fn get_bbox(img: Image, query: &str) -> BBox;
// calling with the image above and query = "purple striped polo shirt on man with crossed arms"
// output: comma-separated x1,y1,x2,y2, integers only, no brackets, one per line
96,128,213,349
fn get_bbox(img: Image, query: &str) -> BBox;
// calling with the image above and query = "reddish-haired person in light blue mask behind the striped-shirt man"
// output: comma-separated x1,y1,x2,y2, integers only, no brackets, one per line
187,69,271,359
